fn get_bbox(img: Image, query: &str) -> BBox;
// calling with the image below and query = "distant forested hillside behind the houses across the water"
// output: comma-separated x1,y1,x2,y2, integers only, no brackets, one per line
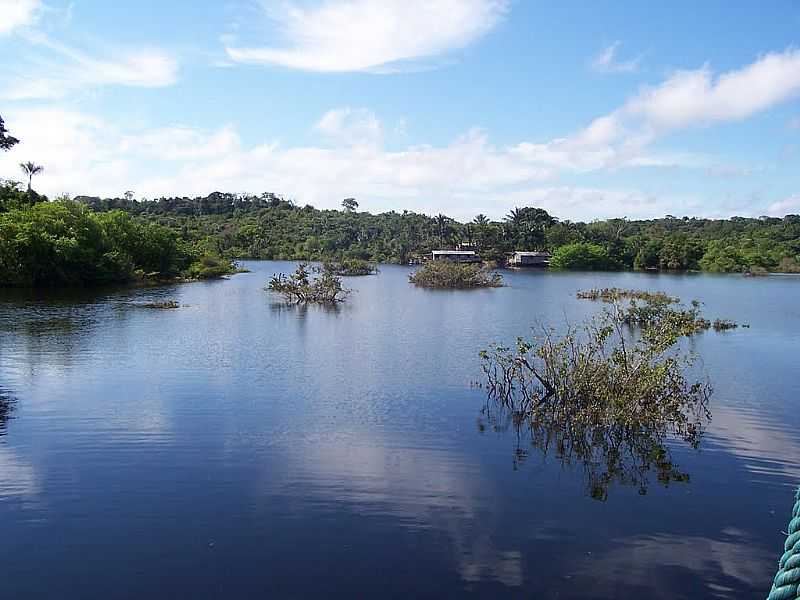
70,192,800,272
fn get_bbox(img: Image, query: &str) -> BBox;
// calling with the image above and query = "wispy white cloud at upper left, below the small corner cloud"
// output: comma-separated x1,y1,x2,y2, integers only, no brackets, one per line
0,35,178,100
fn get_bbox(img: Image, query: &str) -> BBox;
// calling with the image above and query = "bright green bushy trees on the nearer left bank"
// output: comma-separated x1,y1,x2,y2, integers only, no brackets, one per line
0,182,232,287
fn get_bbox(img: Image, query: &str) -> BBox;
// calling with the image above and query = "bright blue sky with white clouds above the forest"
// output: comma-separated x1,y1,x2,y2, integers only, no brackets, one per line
0,0,800,220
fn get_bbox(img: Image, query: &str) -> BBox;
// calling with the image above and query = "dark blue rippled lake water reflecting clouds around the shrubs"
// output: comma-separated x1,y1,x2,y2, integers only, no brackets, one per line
0,263,800,598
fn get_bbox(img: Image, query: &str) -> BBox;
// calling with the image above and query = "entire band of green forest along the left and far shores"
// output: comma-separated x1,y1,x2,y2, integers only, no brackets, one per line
0,181,800,286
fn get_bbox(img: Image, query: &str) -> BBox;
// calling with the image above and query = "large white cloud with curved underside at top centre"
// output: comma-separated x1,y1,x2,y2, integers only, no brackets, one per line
226,0,509,72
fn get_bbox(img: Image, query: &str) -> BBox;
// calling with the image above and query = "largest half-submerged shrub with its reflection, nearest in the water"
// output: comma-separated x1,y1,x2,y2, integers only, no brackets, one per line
481,292,710,500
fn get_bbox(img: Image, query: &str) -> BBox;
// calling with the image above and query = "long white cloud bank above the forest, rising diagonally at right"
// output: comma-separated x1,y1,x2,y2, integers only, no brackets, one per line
0,49,800,219
